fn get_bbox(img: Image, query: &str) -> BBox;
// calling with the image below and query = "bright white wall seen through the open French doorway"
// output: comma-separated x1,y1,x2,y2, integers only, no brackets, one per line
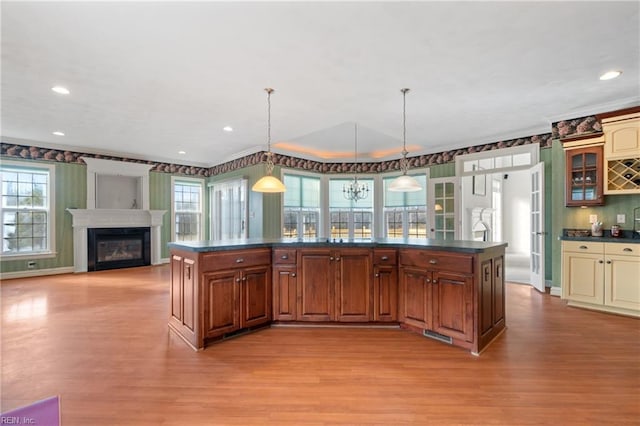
502,170,531,253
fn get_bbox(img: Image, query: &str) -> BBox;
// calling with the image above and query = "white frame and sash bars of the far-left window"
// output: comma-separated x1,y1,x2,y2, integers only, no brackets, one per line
0,159,57,260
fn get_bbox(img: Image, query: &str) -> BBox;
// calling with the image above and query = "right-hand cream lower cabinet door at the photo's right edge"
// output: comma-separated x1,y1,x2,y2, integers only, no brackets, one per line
604,255,640,312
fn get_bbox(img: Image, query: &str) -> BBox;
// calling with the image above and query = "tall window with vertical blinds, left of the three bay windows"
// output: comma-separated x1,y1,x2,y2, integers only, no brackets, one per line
210,179,249,241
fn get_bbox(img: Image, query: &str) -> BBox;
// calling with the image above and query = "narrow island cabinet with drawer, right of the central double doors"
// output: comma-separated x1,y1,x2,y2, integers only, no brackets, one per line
373,249,398,322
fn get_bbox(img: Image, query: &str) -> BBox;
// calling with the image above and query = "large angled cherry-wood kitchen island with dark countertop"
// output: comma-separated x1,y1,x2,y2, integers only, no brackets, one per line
169,239,506,354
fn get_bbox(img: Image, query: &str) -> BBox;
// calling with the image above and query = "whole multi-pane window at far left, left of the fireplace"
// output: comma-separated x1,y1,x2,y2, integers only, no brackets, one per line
0,161,55,257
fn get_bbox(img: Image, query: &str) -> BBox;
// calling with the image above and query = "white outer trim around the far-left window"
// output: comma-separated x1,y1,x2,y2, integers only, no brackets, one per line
0,159,58,260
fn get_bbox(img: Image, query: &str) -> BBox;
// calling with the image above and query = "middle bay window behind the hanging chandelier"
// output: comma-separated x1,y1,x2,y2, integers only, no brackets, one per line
329,179,373,238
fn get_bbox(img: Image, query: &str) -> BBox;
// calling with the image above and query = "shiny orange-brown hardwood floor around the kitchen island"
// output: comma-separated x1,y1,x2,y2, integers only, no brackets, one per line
0,266,640,426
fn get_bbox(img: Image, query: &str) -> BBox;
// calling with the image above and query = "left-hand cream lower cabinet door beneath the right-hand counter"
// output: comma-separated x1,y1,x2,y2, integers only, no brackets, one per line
562,252,604,305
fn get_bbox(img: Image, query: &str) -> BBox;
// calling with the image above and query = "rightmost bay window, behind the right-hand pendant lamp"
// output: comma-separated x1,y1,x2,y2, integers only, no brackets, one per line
383,175,427,238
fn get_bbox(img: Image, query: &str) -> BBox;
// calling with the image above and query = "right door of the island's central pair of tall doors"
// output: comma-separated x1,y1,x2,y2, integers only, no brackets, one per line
334,249,373,322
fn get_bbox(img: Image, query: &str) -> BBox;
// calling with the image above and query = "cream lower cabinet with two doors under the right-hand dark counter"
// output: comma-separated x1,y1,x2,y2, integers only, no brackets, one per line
562,241,640,317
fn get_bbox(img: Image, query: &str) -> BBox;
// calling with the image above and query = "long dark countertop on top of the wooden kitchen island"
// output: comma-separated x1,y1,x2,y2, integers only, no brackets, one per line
168,238,507,253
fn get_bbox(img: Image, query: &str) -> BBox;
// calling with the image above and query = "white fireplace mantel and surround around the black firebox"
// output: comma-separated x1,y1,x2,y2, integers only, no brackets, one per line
67,209,166,272
